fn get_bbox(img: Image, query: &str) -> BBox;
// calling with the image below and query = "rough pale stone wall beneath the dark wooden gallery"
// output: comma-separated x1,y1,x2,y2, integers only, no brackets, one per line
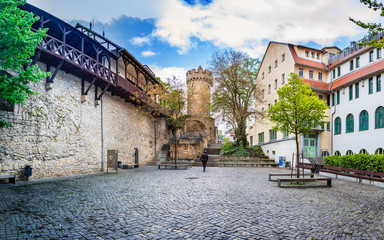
0,64,169,179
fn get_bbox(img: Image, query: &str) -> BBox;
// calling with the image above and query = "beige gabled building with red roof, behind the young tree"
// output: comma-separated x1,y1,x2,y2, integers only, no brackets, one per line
248,42,339,164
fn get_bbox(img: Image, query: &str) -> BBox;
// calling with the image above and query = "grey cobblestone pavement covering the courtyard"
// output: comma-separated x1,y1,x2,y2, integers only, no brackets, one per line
0,167,384,239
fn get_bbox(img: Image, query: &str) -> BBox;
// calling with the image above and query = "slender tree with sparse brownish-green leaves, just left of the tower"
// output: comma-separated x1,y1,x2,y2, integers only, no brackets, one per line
147,77,189,163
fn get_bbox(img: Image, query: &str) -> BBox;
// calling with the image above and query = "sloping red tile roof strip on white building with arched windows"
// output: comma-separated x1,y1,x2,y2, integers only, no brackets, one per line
329,59,384,90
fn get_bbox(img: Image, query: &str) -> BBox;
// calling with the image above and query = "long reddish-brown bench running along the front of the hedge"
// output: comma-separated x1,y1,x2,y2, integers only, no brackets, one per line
320,166,384,182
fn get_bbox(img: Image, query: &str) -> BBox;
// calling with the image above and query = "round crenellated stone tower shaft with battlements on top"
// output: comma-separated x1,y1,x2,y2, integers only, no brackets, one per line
187,66,213,117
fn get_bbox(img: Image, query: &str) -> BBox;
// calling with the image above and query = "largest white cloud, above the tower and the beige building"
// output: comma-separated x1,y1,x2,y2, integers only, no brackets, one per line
154,0,375,56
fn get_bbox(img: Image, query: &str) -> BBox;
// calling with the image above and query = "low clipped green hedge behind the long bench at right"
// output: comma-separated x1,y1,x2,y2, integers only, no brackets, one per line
324,154,384,172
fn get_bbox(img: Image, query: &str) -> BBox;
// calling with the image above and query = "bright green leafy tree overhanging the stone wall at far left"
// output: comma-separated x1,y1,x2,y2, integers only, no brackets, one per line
0,0,47,128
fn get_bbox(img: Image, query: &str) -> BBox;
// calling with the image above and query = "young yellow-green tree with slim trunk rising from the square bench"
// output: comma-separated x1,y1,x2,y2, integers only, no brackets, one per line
266,73,328,177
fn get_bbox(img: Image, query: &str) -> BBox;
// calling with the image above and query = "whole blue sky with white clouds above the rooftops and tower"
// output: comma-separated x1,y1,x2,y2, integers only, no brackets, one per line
27,0,378,80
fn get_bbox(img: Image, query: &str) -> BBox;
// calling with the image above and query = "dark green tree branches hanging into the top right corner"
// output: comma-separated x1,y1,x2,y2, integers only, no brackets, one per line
349,0,384,48
